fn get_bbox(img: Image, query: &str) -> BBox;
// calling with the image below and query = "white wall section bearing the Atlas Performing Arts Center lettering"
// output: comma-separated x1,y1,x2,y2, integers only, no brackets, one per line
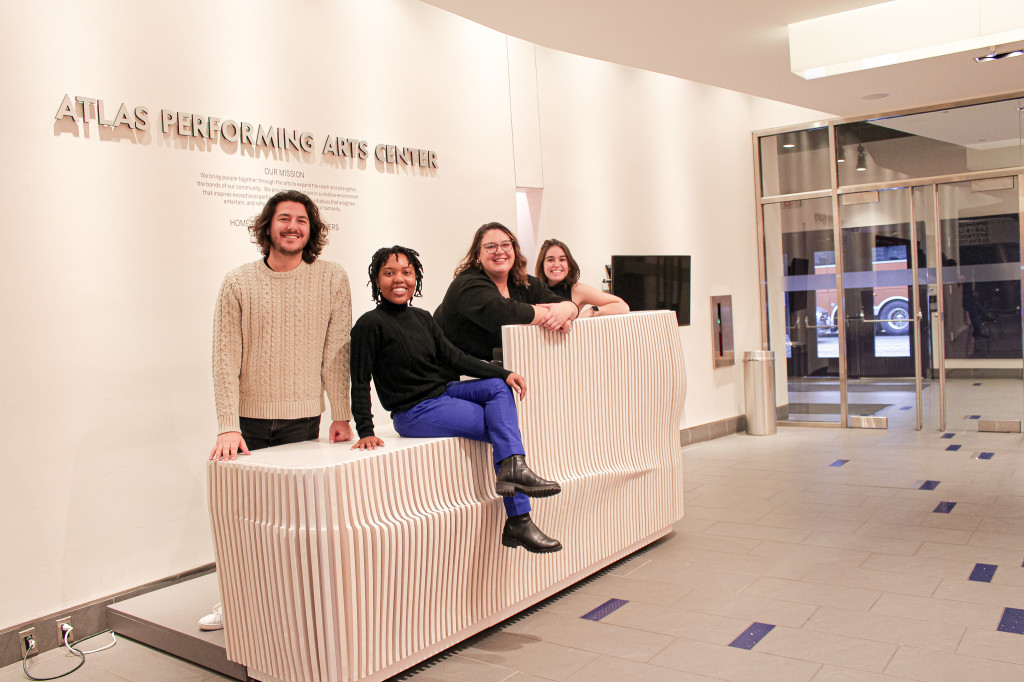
0,0,515,629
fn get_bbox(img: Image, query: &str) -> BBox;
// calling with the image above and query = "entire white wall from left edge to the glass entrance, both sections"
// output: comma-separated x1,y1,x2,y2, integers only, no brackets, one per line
0,0,811,630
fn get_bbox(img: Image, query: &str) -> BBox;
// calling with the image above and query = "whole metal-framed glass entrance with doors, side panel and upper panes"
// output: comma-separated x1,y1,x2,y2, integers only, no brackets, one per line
755,97,1024,432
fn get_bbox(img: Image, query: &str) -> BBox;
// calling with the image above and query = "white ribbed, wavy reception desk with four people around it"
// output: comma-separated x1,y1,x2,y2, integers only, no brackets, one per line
208,311,686,682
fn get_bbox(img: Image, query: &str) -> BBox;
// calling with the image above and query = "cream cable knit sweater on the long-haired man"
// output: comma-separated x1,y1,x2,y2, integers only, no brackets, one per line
213,260,352,433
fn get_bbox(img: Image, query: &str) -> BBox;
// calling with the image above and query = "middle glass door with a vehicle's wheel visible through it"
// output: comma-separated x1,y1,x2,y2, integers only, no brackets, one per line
829,187,931,429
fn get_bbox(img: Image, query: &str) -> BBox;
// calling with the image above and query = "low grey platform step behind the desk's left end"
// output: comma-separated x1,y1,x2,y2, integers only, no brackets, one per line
106,573,248,681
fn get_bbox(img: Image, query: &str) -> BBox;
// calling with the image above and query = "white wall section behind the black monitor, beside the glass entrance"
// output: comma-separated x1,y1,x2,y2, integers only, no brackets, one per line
529,47,820,427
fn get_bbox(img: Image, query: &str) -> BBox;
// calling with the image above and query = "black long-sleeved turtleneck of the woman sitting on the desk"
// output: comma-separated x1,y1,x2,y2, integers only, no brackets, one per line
351,300,512,438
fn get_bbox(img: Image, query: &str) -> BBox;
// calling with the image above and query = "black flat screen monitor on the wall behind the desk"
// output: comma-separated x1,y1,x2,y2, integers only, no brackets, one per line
611,256,690,326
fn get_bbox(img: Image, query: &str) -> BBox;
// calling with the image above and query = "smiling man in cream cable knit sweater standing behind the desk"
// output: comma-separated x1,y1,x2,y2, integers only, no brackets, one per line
200,190,352,630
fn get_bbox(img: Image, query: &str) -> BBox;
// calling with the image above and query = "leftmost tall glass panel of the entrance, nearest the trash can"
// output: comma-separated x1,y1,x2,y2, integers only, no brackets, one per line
763,193,842,425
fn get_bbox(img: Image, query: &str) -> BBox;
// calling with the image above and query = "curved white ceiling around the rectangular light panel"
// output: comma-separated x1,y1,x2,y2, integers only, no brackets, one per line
423,0,1024,117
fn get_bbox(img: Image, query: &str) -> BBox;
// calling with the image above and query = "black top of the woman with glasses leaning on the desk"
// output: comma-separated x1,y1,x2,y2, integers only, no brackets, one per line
434,267,565,360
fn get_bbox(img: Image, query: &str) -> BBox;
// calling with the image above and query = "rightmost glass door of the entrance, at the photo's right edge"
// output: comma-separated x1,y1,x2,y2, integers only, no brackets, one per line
935,177,1024,431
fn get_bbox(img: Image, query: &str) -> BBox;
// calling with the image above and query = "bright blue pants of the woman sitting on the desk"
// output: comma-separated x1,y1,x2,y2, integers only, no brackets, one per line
391,379,529,516
